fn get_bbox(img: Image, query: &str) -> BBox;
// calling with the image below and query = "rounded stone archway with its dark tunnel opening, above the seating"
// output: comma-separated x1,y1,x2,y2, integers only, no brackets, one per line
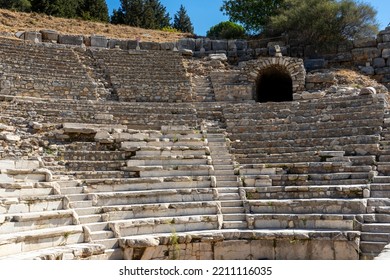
240,57,306,102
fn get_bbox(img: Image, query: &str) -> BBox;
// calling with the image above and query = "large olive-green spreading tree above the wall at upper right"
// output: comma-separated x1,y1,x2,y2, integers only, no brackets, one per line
267,0,378,46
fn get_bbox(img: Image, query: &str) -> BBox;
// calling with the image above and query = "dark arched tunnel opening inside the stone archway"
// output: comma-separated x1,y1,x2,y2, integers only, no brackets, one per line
255,66,293,103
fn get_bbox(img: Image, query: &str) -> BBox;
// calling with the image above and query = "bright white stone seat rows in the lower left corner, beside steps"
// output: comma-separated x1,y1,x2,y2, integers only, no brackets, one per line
0,160,95,259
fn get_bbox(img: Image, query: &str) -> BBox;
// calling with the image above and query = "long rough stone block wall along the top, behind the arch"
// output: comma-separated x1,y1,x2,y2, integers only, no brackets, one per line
16,27,390,88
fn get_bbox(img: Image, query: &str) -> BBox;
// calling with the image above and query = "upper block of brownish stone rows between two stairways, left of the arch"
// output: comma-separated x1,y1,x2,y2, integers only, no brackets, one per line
93,50,192,102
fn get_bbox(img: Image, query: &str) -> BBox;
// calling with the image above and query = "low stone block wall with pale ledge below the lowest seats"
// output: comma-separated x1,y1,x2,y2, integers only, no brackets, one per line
120,230,360,260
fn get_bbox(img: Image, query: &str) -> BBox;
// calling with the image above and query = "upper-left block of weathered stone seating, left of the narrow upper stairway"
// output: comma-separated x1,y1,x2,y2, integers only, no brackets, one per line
0,38,97,100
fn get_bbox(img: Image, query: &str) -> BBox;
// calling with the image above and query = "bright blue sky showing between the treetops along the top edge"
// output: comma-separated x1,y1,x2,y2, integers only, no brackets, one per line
107,0,390,35
